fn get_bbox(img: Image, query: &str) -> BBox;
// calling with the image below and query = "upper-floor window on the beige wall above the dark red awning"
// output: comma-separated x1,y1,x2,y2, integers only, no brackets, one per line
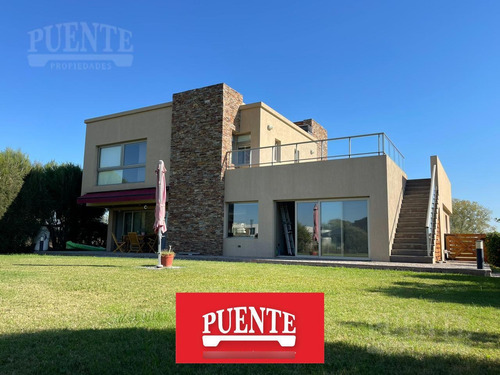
97,141,146,185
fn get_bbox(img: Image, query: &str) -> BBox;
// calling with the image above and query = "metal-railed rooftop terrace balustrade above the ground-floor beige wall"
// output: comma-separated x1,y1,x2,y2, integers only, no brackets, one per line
225,133,404,170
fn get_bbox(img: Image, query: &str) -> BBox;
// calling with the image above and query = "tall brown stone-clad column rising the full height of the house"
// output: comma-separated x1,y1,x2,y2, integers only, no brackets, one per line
167,84,243,255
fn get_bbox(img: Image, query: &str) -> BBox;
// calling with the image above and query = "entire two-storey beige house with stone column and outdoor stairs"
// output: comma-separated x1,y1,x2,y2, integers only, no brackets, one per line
79,84,451,262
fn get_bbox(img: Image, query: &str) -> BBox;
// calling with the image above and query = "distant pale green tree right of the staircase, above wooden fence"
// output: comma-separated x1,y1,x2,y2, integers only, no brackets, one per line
450,198,495,233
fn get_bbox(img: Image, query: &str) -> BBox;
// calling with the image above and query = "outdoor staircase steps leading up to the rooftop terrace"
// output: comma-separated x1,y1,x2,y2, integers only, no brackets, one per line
391,178,433,263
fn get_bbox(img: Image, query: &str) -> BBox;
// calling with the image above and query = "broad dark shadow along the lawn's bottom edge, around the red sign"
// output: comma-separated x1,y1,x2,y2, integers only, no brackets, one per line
0,328,500,374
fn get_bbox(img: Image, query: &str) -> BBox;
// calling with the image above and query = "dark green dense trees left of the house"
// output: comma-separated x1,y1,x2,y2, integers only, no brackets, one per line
0,162,107,252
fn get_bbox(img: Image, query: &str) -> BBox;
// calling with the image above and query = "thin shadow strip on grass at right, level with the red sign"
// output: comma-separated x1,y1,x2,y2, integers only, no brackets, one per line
341,322,500,349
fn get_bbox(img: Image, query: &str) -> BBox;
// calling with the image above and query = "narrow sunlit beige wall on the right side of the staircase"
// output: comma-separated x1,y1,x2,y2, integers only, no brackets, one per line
431,155,453,259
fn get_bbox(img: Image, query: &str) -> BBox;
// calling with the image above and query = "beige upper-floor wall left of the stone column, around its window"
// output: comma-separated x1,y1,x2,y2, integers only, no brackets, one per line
82,103,172,195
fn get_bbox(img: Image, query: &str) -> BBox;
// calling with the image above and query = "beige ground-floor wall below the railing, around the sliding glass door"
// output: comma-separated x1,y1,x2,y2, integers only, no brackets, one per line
223,156,406,261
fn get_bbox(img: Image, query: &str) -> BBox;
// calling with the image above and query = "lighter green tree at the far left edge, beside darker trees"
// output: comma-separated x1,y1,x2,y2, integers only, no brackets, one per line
0,148,31,219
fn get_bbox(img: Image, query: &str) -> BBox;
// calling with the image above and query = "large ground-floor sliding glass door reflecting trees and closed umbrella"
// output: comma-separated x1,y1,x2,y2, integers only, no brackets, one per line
297,200,368,258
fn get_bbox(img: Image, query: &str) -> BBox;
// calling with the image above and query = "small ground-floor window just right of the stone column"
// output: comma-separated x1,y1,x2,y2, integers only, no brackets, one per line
227,203,259,238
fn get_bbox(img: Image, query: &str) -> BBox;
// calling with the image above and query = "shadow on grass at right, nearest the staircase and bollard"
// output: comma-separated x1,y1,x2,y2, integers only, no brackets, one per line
371,275,500,308
